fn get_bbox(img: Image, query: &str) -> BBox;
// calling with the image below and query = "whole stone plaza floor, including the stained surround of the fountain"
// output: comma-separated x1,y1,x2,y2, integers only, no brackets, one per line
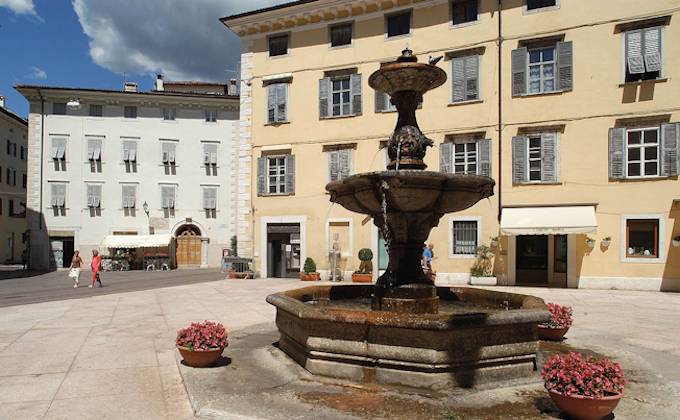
0,279,680,419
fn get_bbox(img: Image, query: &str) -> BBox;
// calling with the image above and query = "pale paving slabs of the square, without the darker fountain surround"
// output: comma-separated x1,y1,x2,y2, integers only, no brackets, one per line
0,279,680,419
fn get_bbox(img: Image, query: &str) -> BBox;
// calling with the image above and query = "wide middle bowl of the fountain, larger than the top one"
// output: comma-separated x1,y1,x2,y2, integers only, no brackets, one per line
326,169,496,215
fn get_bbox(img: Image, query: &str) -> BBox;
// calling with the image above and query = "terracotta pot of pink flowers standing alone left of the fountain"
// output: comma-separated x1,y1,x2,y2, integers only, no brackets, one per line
175,321,229,367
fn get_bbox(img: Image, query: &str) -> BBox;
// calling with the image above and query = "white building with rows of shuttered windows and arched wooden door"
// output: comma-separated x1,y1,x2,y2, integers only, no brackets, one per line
17,83,239,269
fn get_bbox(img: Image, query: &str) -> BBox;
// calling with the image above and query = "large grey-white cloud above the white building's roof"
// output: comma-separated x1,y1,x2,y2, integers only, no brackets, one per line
71,0,287,81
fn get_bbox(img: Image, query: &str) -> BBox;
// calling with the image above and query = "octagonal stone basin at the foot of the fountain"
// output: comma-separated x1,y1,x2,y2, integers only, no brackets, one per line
267,285,550,390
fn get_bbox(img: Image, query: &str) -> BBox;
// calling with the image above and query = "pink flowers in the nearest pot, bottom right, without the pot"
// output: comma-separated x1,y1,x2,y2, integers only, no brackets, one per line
541,352,626,398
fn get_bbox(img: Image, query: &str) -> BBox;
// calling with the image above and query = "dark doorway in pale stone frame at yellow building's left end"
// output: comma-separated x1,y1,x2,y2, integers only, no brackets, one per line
267,223,300,278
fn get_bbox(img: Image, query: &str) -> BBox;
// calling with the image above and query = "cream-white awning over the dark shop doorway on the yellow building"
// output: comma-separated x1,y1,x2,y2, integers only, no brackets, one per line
501,206,597,235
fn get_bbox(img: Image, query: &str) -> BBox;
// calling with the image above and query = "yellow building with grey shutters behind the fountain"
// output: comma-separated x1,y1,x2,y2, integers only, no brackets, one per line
222,0,680,290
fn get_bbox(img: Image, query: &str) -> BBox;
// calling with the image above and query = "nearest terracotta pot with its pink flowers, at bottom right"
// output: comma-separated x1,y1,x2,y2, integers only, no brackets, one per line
541,352,626,420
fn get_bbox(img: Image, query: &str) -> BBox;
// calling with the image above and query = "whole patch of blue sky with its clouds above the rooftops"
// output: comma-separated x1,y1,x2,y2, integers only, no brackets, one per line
0,0,284,117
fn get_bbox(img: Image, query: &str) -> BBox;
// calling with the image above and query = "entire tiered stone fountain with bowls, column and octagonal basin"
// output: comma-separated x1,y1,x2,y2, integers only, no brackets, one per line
267,49,549,389
